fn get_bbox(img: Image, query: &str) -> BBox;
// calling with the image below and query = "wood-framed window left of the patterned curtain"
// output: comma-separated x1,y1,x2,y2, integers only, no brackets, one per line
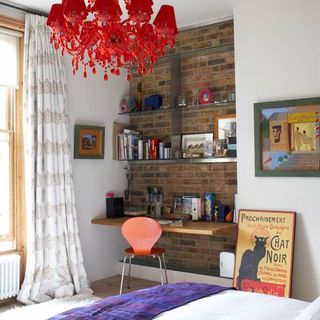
0,19,23,253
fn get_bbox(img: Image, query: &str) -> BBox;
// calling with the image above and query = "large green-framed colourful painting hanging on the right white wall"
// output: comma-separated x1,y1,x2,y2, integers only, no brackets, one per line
254,97,320,177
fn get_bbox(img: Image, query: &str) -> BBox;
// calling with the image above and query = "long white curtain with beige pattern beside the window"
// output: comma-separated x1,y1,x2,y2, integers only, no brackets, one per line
18,15,92,304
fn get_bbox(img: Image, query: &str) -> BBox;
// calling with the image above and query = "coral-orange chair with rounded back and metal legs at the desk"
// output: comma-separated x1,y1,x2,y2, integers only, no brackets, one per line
120,217,168,294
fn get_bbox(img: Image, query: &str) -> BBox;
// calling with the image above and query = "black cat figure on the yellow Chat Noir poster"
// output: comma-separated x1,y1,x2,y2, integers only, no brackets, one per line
237,236,269,290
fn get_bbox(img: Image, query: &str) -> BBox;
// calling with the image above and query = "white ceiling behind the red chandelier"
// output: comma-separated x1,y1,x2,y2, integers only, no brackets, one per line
4,0,247,28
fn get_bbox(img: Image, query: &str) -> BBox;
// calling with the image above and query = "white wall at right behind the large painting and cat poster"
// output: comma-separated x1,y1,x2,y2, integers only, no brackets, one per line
234,0,320,300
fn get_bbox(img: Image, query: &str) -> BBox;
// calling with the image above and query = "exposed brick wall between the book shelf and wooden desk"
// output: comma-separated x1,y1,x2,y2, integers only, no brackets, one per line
130,163,237,207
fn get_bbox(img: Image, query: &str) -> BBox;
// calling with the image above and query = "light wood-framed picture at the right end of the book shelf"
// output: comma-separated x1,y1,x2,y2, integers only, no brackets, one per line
214,114,237,139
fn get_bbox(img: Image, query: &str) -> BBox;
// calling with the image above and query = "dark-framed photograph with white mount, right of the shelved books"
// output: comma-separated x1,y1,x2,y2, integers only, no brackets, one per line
182,133,213,158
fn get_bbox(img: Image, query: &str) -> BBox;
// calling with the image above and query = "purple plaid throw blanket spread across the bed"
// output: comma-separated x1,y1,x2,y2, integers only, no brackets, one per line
50,282,231,320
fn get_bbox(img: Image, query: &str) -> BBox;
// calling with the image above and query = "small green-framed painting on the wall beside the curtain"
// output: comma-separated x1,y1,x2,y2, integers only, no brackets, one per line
74,125,105,159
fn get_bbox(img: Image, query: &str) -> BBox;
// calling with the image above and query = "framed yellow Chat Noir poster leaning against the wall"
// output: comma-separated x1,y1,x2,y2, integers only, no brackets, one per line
233,209,296,297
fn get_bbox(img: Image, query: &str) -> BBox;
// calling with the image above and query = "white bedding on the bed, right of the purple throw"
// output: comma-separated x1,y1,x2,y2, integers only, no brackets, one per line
155,290,309,320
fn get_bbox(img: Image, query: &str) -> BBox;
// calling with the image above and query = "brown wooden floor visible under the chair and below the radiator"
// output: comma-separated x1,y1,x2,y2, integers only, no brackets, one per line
0,276,159,312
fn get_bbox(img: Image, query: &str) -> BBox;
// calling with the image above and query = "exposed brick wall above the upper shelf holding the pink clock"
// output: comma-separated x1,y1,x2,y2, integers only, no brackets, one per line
130,21,235,110
